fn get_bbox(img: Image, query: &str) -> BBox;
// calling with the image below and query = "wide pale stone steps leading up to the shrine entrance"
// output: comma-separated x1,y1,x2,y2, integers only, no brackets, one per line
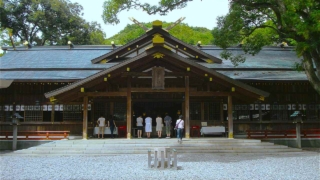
10,138,301,155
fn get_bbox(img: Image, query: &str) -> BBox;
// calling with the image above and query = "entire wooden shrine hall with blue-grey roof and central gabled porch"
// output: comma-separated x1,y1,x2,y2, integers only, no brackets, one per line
0,21,320,139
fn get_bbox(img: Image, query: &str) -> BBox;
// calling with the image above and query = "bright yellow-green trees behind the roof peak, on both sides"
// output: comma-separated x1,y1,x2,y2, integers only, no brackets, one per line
107,22,213,45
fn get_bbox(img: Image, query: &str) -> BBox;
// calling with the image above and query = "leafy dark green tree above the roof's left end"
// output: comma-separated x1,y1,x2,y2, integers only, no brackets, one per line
0,0,105,45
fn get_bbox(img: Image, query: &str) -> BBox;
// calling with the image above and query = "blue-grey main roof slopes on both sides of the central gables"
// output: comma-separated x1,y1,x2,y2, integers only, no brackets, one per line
0,45,308,82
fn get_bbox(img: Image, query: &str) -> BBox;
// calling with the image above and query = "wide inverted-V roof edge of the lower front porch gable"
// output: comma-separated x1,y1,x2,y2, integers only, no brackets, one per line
45,43,269,98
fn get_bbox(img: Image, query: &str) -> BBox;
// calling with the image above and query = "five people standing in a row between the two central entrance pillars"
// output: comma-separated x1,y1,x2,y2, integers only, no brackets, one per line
136,114,184,143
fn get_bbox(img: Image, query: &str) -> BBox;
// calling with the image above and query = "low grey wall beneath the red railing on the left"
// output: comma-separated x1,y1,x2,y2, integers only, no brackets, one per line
0,140,52,150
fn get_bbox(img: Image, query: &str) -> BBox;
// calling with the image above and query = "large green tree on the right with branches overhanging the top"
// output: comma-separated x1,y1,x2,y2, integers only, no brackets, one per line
103,0,320,94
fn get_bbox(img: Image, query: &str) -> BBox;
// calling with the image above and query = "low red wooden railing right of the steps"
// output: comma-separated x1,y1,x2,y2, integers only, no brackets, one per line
247,129,320,139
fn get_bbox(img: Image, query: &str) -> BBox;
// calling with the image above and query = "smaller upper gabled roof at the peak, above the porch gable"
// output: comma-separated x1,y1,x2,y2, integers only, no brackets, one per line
91,22,222,63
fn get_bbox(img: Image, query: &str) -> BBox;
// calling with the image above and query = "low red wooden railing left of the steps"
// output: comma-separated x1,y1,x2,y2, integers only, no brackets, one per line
0,131,70,140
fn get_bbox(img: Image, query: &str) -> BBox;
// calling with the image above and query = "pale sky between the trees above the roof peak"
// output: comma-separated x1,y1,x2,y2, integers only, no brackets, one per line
70,0,229,38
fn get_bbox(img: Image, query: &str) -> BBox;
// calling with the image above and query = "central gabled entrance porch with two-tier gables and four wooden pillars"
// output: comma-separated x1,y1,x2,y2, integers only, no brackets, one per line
45,21,269,139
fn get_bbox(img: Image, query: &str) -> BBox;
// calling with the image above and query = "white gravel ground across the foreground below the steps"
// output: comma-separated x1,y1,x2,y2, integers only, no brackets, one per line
0,151,320,180
